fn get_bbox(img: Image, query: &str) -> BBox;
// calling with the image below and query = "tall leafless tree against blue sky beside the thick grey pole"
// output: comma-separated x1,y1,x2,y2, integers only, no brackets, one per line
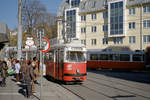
22,0,47,34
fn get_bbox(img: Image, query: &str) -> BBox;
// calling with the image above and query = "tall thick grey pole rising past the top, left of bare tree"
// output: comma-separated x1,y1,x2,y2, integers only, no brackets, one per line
17,0,22,60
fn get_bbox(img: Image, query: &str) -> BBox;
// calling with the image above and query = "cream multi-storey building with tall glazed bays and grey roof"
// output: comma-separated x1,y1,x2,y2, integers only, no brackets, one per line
57,0,150,50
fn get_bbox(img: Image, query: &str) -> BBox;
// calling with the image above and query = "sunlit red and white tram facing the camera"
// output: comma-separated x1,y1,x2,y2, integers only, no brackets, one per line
45,41,87,82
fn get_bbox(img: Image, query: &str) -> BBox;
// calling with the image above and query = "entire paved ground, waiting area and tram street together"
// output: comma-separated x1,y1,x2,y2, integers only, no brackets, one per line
0,70,150,100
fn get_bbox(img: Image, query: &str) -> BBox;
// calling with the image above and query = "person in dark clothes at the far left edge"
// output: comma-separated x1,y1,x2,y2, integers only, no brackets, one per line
1,61,8,87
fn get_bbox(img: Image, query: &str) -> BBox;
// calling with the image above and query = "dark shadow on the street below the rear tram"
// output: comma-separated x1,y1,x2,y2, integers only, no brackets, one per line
87,69,150,84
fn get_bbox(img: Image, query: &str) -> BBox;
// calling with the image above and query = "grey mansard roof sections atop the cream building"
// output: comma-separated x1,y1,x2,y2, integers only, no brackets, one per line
57,0,150,17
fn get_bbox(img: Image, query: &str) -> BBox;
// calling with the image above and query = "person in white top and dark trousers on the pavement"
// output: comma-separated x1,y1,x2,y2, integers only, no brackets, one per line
15,60,21,84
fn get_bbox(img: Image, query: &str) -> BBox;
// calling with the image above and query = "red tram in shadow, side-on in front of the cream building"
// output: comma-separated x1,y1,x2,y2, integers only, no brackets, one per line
87,51,145,70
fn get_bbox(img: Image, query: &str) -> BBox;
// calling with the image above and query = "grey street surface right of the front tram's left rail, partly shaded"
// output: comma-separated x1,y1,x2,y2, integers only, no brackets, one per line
61,70,150,100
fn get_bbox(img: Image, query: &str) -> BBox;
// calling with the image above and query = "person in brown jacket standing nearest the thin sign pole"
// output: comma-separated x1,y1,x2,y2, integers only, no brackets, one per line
25,61,35,98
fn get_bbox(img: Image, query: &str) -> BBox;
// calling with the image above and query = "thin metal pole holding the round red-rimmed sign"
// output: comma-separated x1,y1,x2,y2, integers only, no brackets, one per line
39,31,43,100
